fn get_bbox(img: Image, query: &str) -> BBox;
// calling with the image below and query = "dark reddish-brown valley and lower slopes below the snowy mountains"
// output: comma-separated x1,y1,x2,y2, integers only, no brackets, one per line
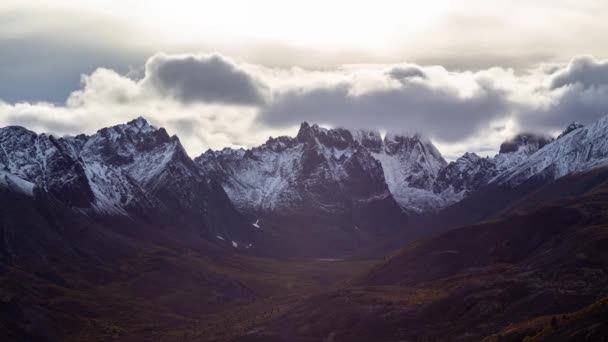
5,169,608,342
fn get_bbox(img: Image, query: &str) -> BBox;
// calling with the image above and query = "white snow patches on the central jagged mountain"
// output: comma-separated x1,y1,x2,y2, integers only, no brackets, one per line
198,125,454,215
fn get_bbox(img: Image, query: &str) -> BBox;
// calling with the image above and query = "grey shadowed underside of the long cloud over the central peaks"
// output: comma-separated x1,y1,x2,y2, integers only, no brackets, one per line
260,78,509,141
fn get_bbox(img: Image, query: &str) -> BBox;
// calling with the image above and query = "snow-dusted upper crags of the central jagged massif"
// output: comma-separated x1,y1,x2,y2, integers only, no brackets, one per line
196,122,447,212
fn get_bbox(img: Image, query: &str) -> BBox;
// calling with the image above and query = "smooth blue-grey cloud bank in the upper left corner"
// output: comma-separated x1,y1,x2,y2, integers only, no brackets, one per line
0,6,155,103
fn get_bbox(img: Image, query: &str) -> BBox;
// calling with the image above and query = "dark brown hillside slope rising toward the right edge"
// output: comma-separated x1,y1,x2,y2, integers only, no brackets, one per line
242,169,608,341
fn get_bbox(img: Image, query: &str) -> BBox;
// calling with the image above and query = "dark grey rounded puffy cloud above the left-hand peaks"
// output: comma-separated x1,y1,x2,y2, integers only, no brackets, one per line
143,54,264,105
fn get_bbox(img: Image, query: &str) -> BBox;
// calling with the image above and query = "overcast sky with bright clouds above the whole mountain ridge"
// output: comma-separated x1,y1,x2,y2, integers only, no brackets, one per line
0,0,608,159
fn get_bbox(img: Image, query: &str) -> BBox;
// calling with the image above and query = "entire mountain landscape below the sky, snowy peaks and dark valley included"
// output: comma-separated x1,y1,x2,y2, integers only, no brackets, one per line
0,117,608,341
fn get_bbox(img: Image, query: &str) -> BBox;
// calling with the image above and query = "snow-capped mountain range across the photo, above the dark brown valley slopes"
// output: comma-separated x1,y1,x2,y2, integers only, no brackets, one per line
7,117,608,256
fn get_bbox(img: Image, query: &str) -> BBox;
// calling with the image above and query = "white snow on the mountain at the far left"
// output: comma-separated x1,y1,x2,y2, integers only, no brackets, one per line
0,118,181,215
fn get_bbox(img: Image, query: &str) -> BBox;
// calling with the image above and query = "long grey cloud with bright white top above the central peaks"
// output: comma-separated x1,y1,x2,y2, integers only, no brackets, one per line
258,64,515,141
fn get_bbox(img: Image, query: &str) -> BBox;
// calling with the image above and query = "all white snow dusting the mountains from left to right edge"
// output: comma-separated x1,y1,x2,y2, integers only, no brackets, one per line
0,117,608,222
